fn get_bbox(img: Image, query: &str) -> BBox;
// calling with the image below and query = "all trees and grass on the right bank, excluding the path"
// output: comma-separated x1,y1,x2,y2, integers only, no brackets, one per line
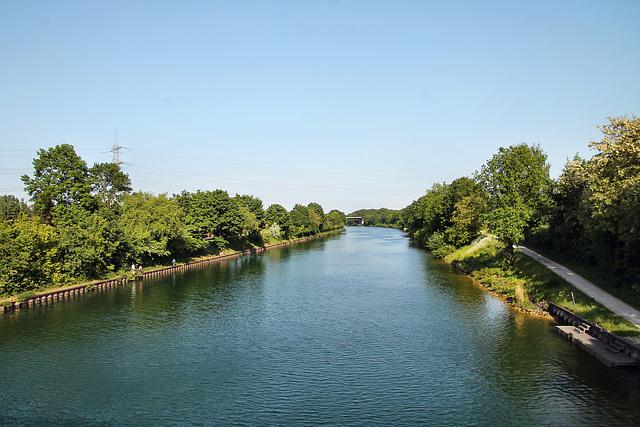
349,116,640,336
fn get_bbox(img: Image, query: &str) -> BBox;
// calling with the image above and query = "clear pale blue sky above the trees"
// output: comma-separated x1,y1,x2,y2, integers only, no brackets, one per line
0,0,640,213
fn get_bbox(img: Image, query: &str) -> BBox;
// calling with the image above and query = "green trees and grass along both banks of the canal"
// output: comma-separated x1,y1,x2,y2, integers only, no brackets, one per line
0,116,640,335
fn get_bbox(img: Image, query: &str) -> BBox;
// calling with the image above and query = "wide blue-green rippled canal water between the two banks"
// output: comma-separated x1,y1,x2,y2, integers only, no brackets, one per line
0,227,640,426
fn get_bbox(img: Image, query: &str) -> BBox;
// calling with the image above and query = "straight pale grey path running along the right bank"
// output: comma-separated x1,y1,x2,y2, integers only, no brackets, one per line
518,246,640,328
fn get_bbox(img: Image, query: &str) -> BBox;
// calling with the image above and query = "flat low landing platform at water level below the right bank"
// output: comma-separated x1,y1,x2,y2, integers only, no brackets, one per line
556,326,640,368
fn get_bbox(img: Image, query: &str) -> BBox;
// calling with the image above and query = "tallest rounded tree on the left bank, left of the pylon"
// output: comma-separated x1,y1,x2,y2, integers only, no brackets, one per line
21,144,95,222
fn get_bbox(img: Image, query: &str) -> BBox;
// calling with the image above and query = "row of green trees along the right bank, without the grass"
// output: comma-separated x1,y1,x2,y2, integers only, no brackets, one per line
349,116,640,289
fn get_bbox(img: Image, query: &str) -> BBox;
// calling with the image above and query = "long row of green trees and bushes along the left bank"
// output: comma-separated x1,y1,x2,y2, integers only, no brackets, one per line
0,144,346,296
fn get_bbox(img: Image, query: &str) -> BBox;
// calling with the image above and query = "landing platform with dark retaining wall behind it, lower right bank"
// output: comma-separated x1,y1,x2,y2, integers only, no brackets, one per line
548,301,640,368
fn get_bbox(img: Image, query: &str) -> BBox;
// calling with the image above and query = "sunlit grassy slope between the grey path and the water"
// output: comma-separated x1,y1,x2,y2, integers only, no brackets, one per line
445,235,640,337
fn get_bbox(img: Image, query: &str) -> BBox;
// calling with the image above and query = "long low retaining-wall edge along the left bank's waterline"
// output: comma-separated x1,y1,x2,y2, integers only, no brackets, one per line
0,228,344,311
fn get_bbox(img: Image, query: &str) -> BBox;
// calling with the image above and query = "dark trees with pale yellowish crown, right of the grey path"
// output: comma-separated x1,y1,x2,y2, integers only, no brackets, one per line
536,116,640,286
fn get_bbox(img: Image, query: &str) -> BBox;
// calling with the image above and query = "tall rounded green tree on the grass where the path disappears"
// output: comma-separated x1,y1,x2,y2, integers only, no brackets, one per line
476,144,551,262
